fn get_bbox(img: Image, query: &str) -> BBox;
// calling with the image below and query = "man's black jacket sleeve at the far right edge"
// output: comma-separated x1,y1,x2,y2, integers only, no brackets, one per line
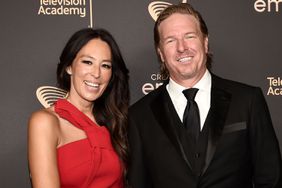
249,88,282,188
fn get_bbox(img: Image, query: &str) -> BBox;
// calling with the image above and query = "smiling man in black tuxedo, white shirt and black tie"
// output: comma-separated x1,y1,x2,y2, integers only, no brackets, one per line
129,4,282,188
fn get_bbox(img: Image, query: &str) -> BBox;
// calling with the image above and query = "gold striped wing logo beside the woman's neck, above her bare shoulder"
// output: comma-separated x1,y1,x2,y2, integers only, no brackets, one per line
36,86,67,108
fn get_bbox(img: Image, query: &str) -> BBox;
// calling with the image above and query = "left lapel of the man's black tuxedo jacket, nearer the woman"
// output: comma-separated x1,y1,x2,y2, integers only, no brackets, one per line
151,84,191,169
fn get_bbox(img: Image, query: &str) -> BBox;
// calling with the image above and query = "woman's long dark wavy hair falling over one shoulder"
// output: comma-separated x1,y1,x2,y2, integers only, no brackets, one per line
57,28,130,182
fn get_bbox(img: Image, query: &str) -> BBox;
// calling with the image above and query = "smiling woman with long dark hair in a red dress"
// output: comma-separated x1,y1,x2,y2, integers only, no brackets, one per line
28,28,129,188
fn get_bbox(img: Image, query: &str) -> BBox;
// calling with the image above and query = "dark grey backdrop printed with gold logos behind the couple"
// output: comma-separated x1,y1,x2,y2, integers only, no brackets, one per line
0,0,282,188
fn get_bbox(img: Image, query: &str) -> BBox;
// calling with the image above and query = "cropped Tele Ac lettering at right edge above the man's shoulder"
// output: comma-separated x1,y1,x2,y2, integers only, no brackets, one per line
267,76,282,96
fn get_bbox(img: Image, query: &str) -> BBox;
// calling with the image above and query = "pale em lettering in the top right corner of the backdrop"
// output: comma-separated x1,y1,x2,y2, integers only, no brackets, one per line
254,0,282,13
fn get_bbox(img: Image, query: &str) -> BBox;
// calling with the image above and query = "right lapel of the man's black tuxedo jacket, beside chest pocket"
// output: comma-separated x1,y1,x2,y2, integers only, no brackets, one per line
202,75,231,174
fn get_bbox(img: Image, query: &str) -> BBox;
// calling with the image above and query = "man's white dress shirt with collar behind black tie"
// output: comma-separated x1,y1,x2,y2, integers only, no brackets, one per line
166,70,211,130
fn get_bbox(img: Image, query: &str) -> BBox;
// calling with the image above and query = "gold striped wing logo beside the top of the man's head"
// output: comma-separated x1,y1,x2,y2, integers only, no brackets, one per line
148,0,187,21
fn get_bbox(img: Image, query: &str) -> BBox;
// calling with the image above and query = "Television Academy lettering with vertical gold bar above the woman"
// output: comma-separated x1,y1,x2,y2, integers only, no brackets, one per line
37,0,93,27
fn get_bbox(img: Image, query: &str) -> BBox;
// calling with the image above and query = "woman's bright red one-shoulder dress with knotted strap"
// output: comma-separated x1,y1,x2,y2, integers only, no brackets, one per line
54,99,123,188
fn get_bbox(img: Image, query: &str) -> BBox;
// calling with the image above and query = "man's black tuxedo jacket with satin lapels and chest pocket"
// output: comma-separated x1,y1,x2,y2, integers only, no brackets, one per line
129,75,282,188
